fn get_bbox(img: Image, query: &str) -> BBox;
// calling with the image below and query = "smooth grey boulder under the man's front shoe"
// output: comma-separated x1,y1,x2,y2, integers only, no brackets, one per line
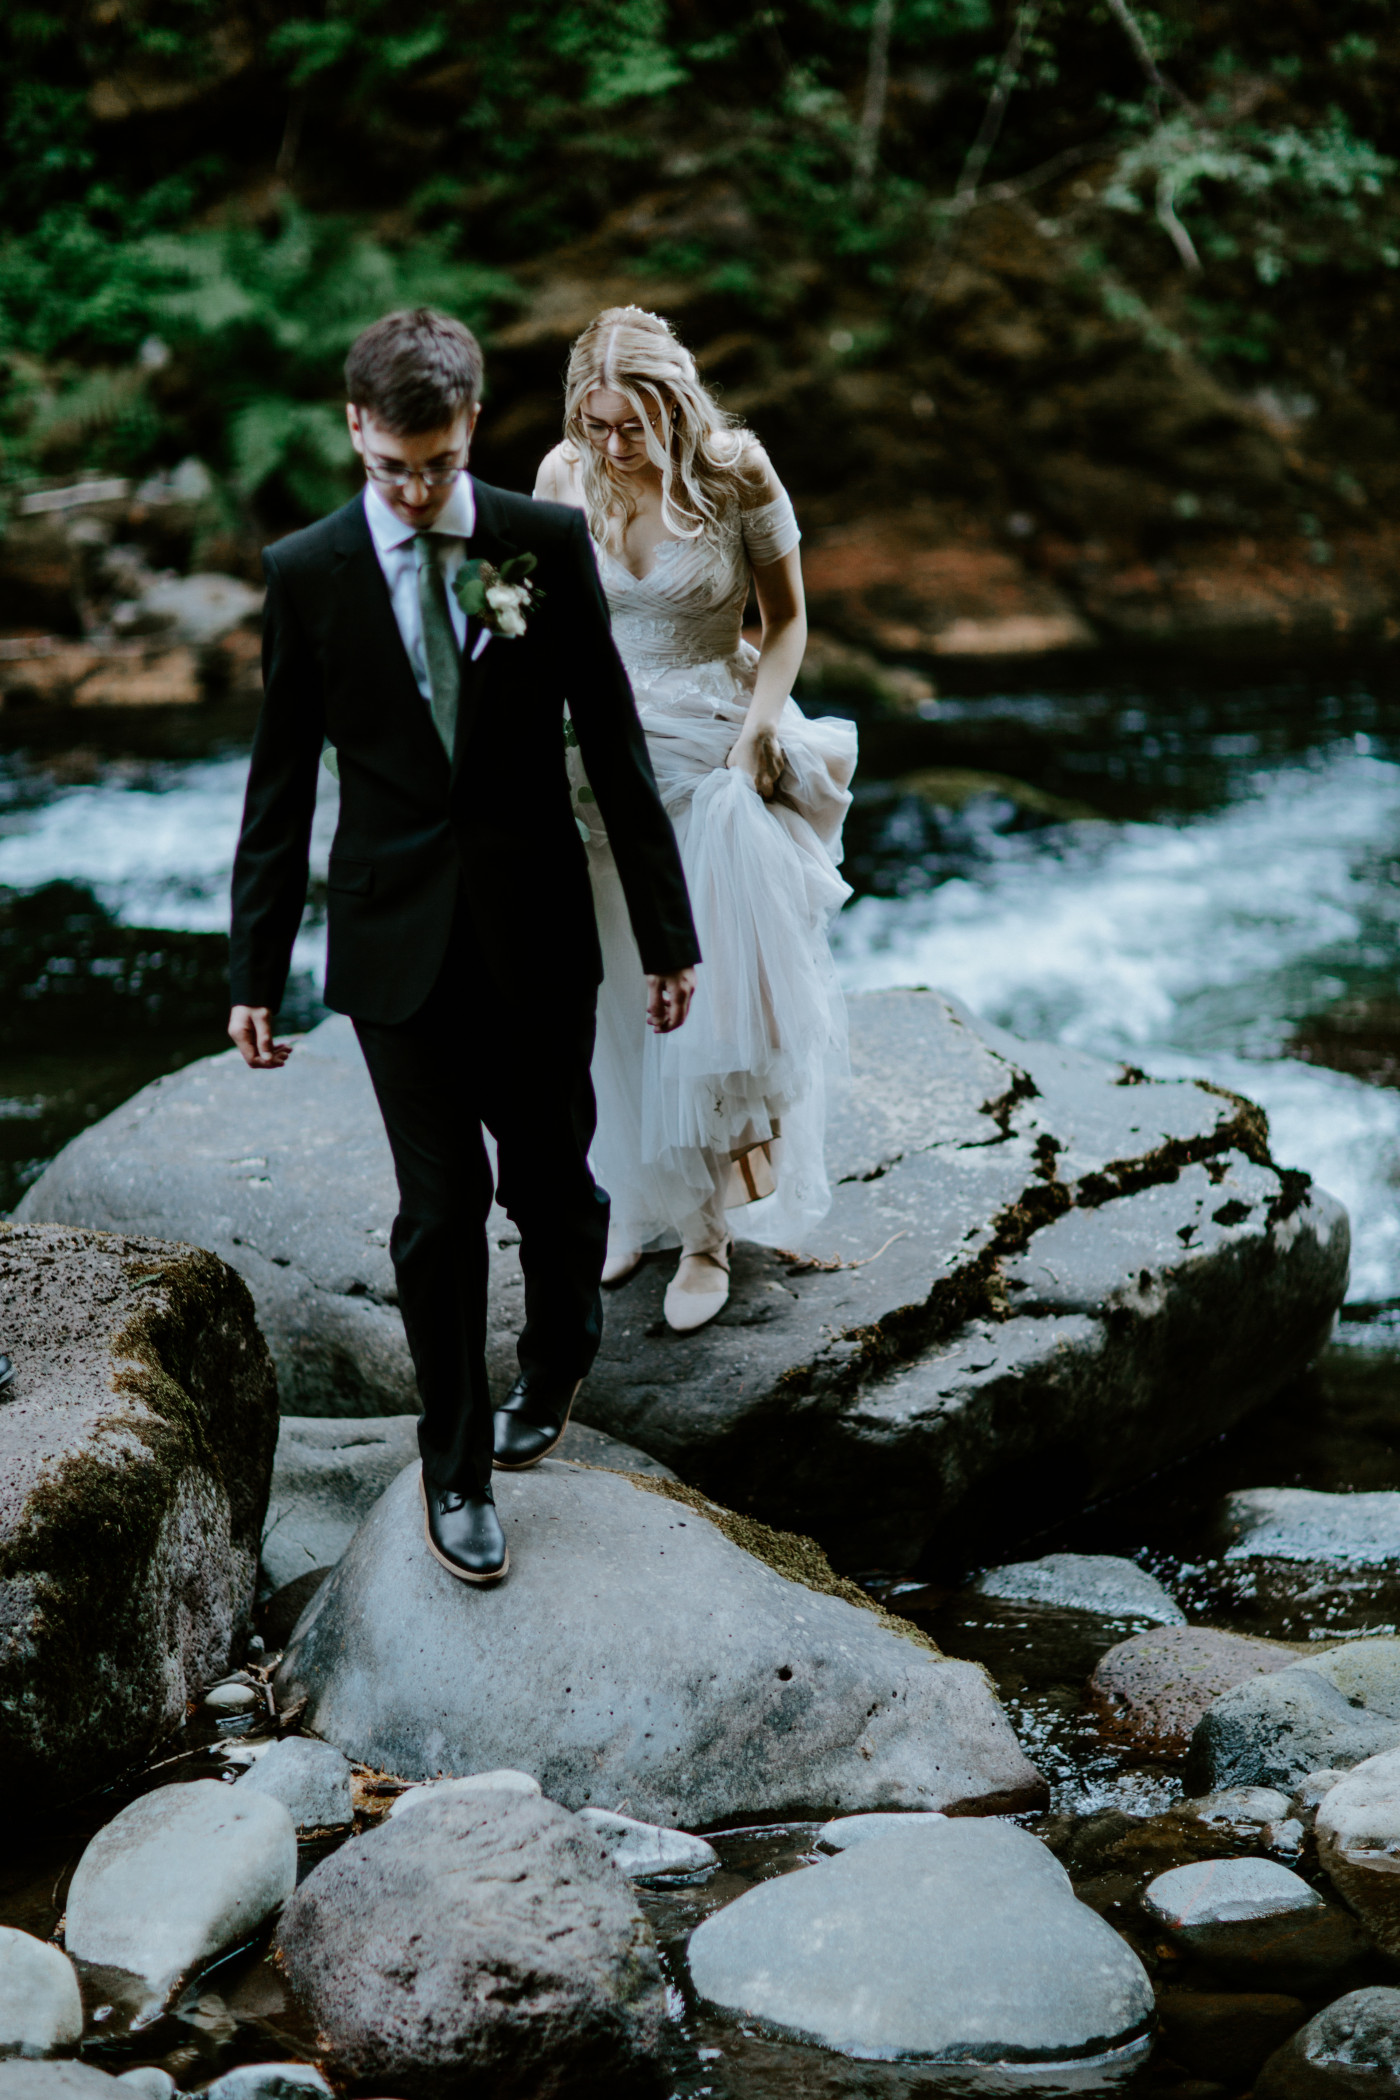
275,1460,1043,1825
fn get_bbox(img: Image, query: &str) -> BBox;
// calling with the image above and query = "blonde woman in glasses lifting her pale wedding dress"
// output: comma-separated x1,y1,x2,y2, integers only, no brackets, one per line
535,307,856,1334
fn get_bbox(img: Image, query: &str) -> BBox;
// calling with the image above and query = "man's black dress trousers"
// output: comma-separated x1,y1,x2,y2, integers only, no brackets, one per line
355,911,609,1495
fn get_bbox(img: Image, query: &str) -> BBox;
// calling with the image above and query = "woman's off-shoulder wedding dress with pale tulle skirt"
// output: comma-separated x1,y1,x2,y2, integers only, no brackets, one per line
569,491,856,1250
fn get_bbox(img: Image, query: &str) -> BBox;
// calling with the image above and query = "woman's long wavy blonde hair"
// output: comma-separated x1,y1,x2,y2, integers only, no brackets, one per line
565,307,749,542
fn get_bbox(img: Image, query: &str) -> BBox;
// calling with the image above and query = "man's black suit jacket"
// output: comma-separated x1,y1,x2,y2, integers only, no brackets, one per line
231,481,699,1023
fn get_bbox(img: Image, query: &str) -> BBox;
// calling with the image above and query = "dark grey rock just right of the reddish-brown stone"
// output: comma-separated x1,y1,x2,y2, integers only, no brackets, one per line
1186,1663,1400,1793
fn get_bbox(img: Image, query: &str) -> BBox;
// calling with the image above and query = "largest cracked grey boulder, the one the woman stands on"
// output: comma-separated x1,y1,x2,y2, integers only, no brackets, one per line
21,991,1348,1567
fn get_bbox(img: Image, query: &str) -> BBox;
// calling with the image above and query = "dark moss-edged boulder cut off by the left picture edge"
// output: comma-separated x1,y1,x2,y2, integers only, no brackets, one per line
0,1226,277,1802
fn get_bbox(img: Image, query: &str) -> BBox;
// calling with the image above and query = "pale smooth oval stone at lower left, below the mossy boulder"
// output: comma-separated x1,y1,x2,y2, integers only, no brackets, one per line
65,1779,296,2006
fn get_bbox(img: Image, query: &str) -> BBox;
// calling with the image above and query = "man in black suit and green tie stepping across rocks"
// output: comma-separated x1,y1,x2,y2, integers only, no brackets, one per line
229,309,699,1583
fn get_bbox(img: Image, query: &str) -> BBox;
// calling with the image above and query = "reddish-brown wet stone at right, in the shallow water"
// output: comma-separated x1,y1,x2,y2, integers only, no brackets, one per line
1089,1625,1293,1755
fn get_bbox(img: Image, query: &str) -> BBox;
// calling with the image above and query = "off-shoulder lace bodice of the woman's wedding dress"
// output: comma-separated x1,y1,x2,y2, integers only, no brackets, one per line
598,489,802,687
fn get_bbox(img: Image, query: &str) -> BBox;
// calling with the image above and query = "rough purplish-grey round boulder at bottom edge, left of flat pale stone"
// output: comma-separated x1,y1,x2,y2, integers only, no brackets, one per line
277,1789,665,2100
